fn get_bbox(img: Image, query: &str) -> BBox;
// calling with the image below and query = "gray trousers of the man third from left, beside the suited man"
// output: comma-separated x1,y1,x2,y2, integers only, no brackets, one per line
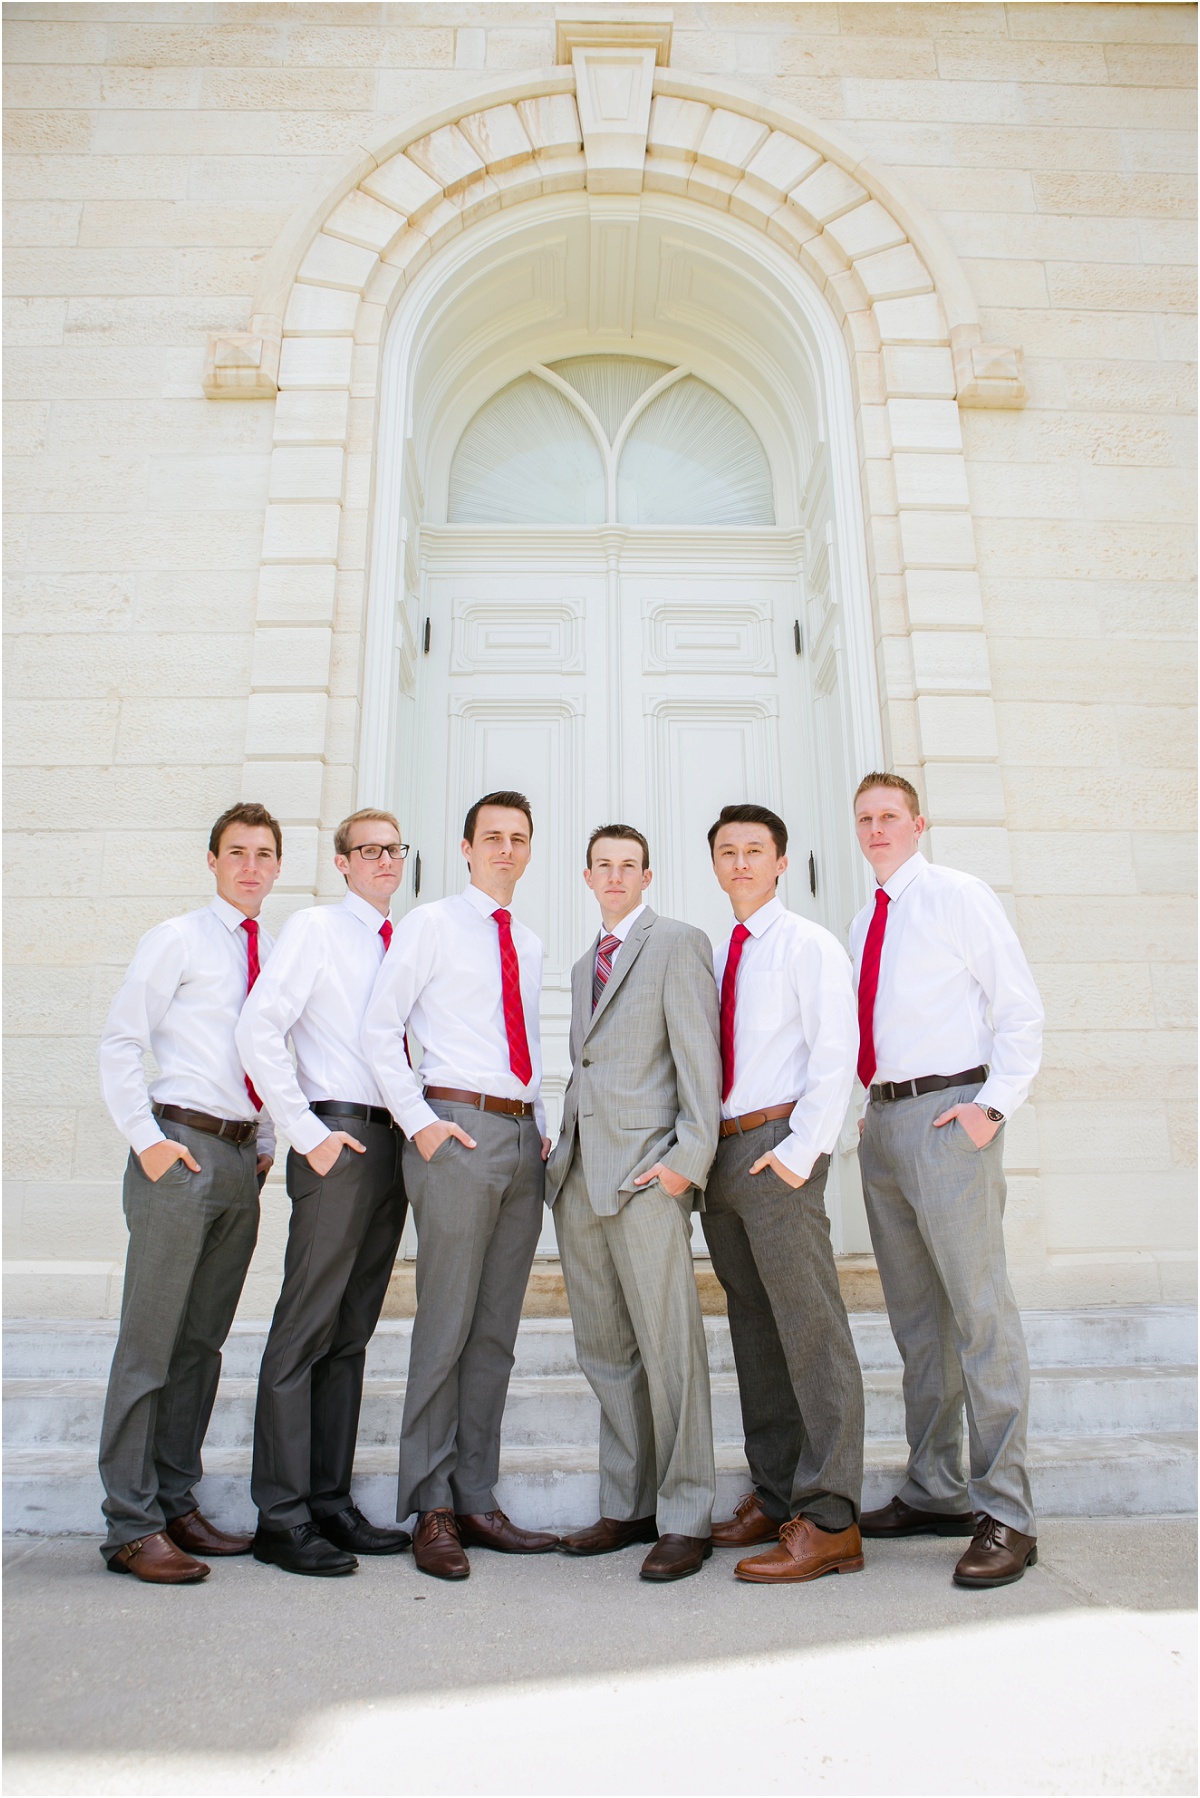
396,1099,545,1523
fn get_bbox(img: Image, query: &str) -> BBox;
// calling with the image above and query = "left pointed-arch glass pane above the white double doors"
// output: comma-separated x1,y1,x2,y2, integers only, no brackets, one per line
450,374,604,525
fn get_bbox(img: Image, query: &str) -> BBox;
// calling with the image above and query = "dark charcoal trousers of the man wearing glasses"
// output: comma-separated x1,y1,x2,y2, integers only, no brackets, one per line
250,1118,407,1530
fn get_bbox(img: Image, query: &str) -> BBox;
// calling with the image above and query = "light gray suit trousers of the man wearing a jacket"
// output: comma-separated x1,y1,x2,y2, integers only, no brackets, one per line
554,1154,716,1535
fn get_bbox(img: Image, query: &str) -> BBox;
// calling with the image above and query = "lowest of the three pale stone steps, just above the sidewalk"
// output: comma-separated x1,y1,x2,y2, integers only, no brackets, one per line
4,1431,1196,1555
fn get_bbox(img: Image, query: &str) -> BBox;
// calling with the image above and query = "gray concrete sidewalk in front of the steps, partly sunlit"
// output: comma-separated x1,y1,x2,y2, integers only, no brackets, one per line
5,1518,1196,1794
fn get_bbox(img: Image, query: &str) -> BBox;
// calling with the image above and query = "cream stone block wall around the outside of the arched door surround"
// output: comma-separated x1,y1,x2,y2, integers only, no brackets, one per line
5,4,1195,1314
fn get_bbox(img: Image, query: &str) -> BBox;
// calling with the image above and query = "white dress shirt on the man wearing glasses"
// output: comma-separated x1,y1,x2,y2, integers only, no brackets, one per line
237,894,395,1154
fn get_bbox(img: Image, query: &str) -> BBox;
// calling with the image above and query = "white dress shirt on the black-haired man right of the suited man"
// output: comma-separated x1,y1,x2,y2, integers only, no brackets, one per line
712,899,858,1179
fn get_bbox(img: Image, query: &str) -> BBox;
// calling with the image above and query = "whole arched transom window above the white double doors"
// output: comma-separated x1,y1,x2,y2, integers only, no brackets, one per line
448,356,775,525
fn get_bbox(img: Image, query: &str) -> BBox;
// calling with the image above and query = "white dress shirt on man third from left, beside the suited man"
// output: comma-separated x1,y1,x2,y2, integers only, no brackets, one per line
362,885,545,1136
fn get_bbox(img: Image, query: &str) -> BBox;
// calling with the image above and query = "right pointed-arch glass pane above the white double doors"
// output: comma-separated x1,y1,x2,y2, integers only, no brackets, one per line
617,374,775,525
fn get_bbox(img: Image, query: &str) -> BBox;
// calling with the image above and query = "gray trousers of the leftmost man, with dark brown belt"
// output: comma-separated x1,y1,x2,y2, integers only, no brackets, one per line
99,1120,259,1561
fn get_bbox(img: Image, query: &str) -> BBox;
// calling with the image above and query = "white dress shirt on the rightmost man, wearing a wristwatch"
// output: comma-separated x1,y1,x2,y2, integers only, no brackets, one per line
849,850,1045,1118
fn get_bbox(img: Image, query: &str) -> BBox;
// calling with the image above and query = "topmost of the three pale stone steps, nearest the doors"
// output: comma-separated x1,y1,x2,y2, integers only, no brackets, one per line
4,1305,1196,1379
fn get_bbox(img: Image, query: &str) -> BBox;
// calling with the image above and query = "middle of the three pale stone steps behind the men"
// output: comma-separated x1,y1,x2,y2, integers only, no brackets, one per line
4,1366,1196,1447
